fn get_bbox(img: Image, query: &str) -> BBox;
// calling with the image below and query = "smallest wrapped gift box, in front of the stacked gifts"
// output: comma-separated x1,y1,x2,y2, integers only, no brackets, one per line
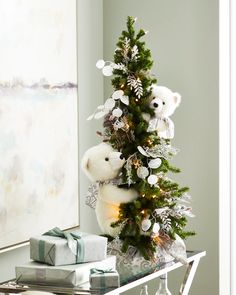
89,268,120,289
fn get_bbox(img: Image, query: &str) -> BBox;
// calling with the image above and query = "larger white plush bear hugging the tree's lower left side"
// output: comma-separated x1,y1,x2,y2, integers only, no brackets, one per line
81,143,138,237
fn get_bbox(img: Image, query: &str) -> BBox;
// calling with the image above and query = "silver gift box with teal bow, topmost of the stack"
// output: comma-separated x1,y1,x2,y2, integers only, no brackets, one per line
30,227,107,265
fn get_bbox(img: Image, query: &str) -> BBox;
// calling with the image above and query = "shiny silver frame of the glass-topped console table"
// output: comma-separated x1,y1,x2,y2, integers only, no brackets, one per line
0,251,206,295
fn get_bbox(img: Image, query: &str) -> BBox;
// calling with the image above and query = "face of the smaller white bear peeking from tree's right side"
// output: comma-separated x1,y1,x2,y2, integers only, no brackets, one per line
150,85,181,117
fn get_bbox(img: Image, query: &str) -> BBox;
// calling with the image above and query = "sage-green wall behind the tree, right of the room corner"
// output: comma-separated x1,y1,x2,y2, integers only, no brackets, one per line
103,0,219,295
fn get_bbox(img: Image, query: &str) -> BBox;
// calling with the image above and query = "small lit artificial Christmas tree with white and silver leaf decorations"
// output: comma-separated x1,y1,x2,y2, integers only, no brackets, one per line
85,17,194,259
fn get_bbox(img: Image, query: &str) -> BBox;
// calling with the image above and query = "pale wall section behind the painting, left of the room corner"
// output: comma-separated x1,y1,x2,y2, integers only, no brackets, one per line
0,0,103,282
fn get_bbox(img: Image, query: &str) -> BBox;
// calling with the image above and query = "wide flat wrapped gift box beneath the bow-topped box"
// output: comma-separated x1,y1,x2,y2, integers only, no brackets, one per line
16,256,116,287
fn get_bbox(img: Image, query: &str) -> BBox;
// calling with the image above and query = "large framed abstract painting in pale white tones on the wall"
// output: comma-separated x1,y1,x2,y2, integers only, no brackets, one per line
0,0,79,249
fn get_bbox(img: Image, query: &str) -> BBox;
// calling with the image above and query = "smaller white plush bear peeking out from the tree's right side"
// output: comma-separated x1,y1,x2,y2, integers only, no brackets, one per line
143,85,181,139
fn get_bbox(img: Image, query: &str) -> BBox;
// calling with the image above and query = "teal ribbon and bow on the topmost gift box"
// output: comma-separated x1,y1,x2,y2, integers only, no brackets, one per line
39,227,84,263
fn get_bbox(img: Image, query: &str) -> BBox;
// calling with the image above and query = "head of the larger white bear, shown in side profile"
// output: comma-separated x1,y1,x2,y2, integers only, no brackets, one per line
82,143,125,181
